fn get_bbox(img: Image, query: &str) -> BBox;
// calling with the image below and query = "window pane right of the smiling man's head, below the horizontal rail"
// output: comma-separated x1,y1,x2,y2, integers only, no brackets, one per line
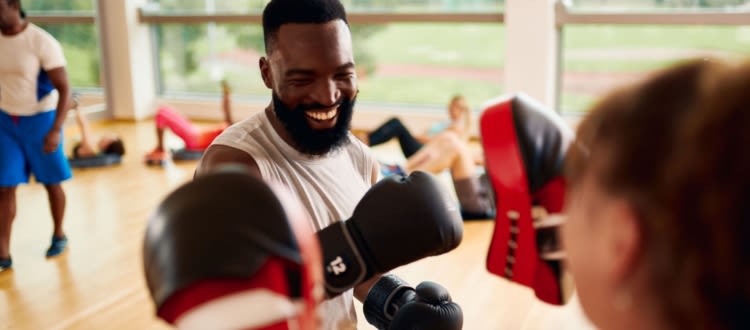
354,23,505,106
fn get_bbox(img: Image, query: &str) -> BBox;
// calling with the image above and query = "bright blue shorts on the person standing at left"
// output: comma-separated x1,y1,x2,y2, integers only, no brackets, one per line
0,110,72,187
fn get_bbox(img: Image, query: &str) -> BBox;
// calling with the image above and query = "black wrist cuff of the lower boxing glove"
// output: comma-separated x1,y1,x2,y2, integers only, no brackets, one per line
363,274,416,330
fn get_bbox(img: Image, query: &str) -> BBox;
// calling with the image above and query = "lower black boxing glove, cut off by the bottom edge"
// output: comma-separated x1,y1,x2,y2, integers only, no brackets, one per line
363,274,463,330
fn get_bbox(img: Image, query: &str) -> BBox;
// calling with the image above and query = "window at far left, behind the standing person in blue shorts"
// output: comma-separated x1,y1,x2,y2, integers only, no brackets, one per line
26,0,101,88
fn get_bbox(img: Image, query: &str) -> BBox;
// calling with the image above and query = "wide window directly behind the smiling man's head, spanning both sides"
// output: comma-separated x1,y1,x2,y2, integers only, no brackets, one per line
144,0,505,110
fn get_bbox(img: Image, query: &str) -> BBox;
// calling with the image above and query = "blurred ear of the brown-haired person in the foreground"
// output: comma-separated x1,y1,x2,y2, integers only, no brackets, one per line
606,200,643,282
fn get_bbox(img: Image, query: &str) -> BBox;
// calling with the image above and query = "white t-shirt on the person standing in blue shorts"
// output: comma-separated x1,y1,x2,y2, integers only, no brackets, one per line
0,23,66,116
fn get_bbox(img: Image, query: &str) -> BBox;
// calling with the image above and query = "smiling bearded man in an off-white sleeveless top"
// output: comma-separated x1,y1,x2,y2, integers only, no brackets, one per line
196,0,462,329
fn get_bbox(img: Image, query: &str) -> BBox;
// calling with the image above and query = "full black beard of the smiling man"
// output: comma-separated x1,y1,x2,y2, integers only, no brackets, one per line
272,93,356,156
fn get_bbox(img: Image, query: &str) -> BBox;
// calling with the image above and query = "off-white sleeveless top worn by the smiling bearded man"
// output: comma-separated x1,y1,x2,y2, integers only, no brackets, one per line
212,111,375,330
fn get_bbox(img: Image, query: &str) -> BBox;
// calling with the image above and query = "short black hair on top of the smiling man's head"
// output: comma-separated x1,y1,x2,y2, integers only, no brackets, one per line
263,0,349,54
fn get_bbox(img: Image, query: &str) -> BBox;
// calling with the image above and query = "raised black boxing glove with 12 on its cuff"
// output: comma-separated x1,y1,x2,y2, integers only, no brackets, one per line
318,172,463,296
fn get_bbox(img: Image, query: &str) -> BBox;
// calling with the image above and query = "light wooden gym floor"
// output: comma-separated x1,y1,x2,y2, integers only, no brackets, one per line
0,121,589,330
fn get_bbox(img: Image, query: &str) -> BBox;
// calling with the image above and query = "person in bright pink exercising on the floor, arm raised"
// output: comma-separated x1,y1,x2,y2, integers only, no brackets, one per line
145,80,232,165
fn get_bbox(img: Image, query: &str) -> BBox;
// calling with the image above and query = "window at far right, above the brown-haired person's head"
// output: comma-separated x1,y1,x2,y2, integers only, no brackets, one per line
560,0,750,112
